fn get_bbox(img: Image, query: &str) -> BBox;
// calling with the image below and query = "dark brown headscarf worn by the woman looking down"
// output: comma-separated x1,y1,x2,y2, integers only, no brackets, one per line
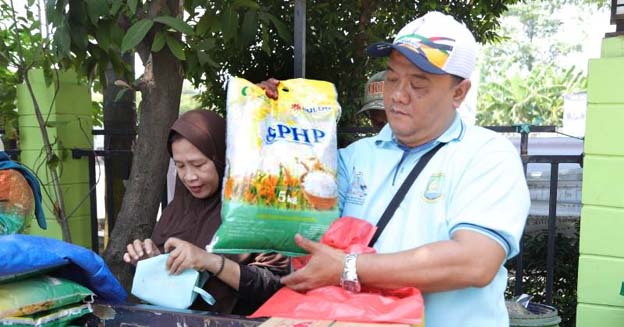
152,109,225,250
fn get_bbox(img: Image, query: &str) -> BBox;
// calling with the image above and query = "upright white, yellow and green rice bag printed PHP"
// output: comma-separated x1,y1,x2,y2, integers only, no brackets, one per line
213,77,340,255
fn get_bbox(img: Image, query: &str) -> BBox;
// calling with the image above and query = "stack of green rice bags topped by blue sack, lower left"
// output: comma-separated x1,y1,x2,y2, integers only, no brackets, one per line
0,234,127,326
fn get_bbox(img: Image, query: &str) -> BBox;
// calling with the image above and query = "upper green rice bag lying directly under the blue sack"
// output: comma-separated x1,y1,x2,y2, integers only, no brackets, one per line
0,275,93,318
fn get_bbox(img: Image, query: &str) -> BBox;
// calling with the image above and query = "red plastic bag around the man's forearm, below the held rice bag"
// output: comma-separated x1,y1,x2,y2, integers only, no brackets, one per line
250,217,424,325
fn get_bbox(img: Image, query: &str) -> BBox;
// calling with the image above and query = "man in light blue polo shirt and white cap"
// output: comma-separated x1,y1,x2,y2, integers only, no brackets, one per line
282,12,529,327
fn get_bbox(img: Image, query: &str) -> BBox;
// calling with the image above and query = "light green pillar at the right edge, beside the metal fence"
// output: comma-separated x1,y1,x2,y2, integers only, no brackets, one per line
577,36,624,327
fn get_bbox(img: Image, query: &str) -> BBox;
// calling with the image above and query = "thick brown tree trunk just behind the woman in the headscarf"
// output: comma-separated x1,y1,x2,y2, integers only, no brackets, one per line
104,49,183,289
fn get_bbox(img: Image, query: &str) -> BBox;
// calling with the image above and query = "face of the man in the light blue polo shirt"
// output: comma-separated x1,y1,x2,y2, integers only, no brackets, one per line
384,51,470,147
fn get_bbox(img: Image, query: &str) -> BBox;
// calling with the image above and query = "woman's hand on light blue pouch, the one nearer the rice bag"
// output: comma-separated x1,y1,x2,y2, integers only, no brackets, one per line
165,237,221,275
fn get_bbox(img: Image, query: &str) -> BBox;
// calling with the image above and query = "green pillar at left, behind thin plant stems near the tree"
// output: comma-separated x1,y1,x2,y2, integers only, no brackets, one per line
17,70,93,247
